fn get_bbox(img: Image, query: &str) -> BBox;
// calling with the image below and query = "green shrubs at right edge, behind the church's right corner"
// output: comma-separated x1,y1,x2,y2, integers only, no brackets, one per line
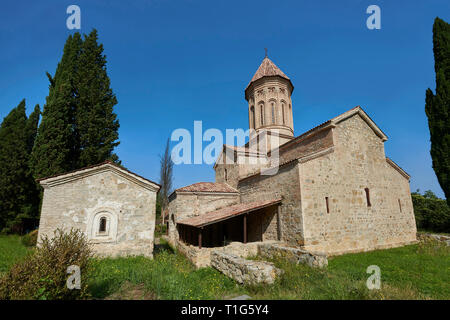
411,191,450,232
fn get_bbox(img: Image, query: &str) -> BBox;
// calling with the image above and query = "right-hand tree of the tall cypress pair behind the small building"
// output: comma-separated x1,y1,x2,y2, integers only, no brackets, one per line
75,29,119,167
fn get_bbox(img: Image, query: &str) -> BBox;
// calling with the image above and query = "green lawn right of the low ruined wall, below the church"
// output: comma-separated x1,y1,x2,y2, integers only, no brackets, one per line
248,242,450,299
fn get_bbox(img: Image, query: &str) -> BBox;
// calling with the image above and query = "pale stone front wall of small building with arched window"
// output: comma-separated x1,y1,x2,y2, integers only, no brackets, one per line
39,171,156,257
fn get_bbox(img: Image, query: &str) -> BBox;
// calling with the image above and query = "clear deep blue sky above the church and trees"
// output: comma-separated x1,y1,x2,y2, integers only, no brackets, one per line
0,0,450,197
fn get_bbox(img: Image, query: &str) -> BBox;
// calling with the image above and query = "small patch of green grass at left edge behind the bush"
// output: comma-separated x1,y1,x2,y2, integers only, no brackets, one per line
0,235,33,274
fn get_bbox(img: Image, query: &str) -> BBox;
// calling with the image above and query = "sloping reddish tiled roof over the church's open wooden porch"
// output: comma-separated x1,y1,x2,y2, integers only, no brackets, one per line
177,199,281,228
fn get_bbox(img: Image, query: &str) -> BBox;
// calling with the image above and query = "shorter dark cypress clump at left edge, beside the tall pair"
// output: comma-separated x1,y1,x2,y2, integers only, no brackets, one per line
0,100,39,232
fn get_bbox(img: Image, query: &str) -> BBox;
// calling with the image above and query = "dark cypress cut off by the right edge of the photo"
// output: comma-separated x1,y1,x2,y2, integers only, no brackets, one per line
425,18,450,205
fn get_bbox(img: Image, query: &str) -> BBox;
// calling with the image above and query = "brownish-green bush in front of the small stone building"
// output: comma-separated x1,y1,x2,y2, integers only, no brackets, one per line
0,229,92,300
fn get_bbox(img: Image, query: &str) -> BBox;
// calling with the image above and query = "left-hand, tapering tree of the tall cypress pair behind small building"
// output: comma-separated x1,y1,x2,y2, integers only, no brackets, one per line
30,33,82,178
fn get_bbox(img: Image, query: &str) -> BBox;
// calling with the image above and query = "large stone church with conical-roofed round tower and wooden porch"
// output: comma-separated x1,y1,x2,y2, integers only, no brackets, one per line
169,57,416,266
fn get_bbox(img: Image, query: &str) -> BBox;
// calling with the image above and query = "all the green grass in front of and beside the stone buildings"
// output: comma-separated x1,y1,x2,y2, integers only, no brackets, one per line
0,237,450,299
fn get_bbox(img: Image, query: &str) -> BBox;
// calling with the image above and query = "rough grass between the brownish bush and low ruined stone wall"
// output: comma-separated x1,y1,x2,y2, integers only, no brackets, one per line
89,245,241,300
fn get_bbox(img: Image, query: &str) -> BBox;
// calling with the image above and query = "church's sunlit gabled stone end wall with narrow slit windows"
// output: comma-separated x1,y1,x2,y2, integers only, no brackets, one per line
298,114,416,254
